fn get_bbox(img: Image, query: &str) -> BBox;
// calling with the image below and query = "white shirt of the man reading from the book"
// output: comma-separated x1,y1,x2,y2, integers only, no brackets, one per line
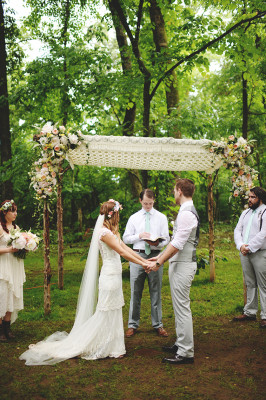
123,208,170,250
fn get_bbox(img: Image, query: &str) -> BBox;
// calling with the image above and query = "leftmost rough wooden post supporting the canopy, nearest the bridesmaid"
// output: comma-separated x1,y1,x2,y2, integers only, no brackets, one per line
43,201,52,315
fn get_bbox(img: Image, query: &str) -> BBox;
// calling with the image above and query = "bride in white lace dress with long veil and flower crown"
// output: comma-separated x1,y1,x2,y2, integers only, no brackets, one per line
20,200,148,365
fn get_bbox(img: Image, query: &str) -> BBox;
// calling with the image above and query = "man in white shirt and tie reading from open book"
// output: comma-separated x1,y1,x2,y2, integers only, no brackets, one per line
123,189,170,337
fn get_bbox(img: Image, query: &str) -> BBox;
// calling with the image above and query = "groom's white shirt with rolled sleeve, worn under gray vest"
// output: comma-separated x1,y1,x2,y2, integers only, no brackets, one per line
171,200,198,250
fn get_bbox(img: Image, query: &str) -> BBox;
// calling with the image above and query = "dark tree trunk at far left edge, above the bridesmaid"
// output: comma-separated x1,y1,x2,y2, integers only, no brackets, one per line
0,0,13,200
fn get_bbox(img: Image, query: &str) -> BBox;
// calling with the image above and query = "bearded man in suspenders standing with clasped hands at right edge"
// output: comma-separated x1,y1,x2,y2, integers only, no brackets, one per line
233,187,266,328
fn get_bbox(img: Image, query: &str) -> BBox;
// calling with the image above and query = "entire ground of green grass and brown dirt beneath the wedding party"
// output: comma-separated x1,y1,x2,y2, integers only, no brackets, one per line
0,225,266,400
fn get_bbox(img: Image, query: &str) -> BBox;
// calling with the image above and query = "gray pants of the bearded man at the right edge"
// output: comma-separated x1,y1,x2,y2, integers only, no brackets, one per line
240,250,266,319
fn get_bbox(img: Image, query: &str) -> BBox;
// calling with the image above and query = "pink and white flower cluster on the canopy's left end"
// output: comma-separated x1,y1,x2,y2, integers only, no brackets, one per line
29,124,88,200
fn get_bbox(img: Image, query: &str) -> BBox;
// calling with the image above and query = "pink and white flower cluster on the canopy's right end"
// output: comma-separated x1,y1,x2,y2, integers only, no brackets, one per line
209,135,257,198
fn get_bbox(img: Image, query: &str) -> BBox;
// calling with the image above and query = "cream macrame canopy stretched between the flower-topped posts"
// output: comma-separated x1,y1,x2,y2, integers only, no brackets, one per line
67,135,222,174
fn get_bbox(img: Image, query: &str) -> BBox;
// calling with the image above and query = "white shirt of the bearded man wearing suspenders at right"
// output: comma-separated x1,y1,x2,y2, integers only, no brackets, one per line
234,204,266,253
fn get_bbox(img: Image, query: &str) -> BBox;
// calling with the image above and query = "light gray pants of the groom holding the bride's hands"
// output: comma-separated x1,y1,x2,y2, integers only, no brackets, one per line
169,261,197,357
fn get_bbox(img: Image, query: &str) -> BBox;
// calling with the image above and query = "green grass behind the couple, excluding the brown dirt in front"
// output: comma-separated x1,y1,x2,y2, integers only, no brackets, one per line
19,226,247,323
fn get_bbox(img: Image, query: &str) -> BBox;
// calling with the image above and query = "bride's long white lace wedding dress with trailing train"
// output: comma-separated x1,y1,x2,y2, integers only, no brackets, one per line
20,222,126,365
